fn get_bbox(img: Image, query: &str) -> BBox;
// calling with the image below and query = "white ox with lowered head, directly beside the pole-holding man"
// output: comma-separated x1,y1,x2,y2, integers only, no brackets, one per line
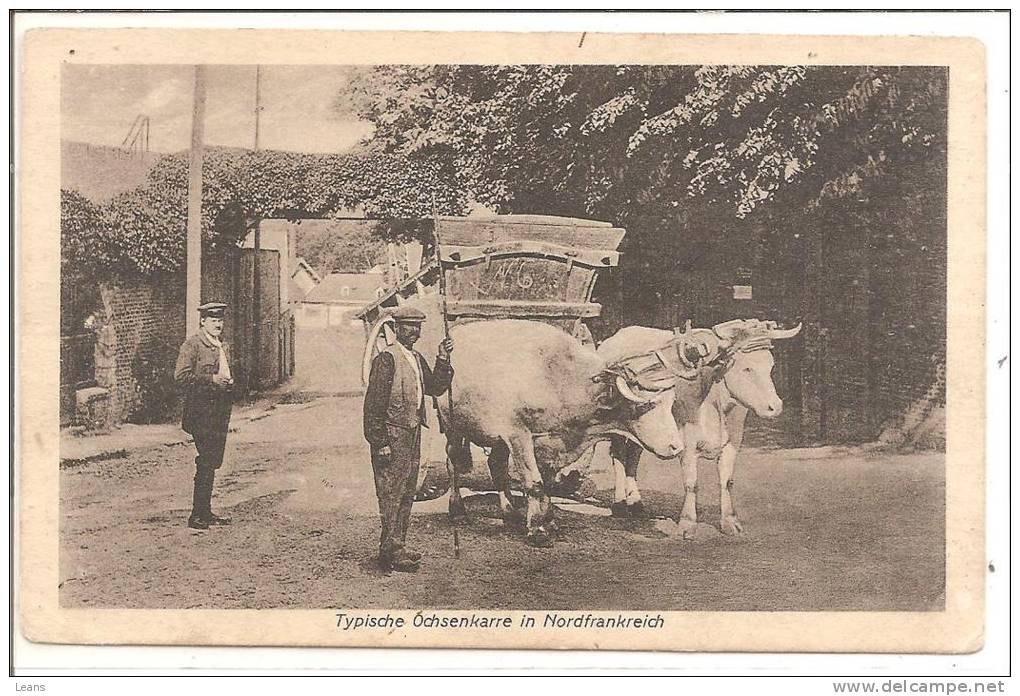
439,319,683,546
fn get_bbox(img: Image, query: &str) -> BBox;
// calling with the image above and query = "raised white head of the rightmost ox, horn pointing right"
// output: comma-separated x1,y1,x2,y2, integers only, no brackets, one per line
713,319,801,418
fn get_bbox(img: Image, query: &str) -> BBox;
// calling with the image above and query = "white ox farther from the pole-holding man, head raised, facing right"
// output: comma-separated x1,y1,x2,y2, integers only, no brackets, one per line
599,319,801,537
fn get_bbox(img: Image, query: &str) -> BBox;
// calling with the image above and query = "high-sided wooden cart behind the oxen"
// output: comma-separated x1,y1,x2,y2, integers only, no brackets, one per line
357,215,625,484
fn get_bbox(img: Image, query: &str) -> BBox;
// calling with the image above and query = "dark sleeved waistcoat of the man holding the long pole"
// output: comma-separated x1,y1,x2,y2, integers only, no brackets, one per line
364,345,453,447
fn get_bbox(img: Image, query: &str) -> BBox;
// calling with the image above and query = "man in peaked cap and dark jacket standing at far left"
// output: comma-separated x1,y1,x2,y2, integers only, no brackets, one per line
173,302,234,530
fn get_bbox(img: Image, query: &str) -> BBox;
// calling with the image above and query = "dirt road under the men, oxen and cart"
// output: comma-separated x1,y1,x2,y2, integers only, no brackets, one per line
60,324,945,610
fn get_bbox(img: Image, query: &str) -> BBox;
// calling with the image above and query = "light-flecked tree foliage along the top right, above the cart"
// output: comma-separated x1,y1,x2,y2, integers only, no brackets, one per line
338,65,946,219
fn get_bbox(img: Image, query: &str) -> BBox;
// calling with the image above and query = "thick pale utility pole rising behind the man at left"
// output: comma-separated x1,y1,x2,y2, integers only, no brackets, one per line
185,65,205,336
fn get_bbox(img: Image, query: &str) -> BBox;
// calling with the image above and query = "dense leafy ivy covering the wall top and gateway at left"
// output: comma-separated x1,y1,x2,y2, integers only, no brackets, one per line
61,149,463,276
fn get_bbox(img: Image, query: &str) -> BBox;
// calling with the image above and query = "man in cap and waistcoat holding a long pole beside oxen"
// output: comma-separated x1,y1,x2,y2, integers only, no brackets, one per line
364,305,453,573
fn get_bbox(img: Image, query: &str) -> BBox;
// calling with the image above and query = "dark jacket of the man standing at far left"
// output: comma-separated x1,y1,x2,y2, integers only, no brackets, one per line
173,332,236,435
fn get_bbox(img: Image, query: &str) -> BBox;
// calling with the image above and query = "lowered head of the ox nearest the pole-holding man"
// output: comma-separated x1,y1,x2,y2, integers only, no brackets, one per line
595,358,683,459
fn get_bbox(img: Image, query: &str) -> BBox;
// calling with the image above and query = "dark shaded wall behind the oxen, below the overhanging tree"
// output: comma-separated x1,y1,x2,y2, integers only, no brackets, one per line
593,159,947,446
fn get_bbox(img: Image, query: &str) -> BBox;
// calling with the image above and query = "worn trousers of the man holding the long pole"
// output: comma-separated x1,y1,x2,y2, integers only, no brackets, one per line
372,426,421,558
